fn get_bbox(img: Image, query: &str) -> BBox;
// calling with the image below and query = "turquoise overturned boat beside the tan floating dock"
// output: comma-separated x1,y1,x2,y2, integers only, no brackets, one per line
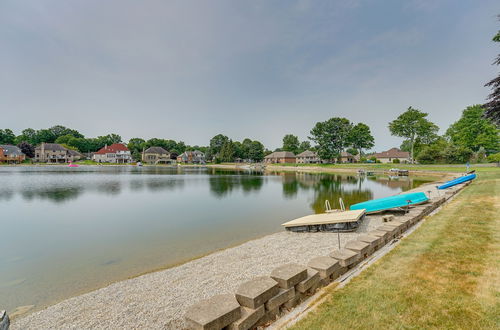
350,192,429,213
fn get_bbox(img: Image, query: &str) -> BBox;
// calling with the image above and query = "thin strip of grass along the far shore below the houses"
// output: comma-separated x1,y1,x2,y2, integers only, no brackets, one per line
269,163,500,173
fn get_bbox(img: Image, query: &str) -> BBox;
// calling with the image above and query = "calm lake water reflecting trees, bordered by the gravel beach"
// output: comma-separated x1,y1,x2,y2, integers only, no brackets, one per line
0,166,430,311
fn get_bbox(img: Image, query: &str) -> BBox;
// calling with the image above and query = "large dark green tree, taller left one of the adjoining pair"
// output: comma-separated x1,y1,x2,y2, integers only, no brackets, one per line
309,117,352,160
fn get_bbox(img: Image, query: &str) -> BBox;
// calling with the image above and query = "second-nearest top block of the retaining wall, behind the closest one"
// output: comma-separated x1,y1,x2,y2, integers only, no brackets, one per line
236,276,279,309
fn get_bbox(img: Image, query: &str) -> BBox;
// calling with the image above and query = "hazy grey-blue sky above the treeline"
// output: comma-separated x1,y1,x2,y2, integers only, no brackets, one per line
0,0,500,151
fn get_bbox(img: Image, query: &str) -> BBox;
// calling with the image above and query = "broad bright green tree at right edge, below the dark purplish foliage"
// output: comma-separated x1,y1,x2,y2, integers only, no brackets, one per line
446,105,500,154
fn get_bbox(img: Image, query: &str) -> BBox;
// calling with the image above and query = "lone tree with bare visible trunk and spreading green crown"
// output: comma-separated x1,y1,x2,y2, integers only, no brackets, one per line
389,107,439,163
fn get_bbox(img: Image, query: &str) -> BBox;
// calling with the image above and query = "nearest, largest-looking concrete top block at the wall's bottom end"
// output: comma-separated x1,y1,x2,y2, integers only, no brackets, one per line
184,294,241,330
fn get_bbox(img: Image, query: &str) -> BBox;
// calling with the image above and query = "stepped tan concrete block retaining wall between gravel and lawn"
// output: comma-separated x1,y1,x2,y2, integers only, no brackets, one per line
185,185,466,330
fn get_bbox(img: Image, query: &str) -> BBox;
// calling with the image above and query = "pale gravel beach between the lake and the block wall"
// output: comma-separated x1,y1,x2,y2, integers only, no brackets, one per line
11,216,382,329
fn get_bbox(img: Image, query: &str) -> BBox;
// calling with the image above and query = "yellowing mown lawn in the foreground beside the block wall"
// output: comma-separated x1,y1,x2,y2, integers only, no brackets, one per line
293,168,500,329
